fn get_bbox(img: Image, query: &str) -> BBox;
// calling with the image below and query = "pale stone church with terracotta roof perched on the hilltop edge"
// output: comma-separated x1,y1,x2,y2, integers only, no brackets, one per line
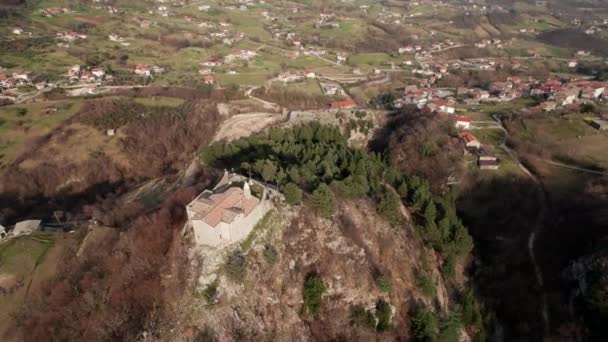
186,173,272,248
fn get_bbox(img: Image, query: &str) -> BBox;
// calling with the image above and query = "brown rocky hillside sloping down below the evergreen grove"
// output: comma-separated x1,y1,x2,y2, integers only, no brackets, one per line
168,200,449,341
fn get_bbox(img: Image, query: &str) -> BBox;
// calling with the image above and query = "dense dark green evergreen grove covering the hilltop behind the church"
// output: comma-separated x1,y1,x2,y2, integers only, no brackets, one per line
200,122,472,257
